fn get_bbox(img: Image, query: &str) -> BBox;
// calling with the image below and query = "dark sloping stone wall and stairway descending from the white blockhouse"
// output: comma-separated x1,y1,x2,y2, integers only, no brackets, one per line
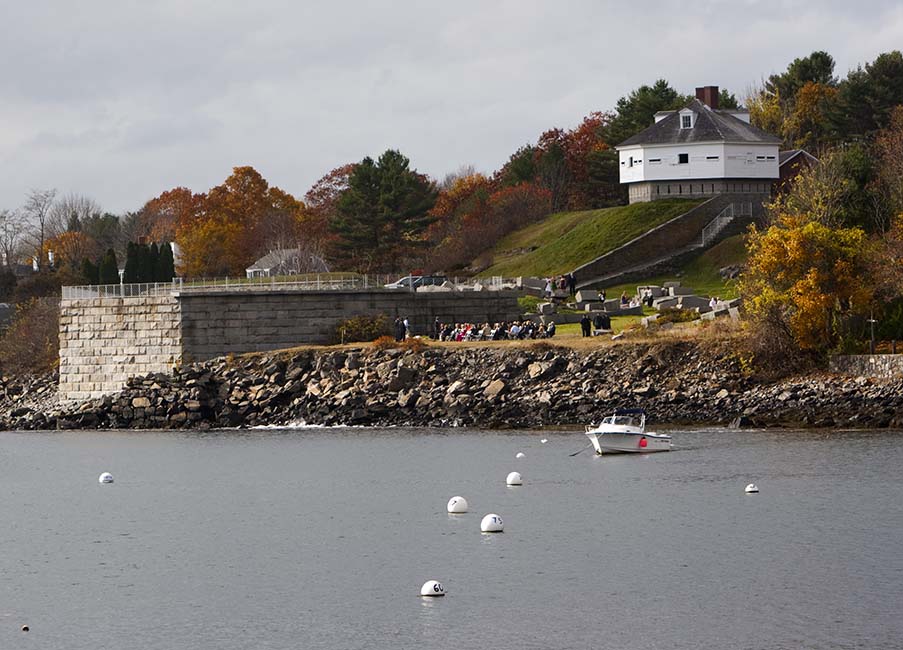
573,194,762,289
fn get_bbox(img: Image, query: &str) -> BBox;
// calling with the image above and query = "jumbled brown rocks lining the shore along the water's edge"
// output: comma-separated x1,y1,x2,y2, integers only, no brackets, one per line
0,341,903,429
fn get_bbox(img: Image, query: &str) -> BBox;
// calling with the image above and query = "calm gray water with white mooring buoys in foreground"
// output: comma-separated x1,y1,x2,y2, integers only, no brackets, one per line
0,430,903,650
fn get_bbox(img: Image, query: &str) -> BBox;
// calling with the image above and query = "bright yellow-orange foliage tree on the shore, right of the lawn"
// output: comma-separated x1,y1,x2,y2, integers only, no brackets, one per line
741,214,874,351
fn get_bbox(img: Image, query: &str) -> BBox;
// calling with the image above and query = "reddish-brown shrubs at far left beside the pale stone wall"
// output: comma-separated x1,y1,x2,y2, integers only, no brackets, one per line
0,298,60,375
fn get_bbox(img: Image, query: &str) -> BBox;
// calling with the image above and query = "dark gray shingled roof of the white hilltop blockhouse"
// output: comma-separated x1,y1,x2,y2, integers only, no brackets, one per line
618,99,781,147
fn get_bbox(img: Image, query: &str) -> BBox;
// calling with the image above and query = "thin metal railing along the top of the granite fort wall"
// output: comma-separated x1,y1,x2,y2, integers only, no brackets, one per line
63,273,520,300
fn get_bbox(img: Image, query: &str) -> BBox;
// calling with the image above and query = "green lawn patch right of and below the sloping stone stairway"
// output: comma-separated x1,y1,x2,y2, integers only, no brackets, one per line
605,235,746,298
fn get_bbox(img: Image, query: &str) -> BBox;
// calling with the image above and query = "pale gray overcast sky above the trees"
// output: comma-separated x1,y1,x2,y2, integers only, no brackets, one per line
0,0,903,212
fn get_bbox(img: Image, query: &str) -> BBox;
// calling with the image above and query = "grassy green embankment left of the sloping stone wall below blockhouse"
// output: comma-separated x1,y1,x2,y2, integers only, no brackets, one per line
480,199,700,277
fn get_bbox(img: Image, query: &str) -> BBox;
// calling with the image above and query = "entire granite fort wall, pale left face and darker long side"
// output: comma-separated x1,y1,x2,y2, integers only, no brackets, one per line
60,290,519,402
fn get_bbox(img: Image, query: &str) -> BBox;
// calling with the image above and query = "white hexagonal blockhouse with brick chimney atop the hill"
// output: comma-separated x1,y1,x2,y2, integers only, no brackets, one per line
616,86,781,203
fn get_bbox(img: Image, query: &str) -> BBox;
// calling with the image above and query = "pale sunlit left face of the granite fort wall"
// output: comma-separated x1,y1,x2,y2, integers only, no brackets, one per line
59,296,182,401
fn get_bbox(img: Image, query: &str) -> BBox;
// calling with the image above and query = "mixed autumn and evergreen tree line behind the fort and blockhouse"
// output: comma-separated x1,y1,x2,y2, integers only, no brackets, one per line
0,51,903,293
